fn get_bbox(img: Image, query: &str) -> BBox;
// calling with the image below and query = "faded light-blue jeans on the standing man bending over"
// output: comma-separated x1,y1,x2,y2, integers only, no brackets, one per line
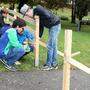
46,24,61,67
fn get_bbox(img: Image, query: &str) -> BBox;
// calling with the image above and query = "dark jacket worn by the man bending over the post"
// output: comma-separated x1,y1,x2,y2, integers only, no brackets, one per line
33,5,60,37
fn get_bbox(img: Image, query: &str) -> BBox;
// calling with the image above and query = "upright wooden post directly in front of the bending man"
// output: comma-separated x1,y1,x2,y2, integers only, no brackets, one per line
35,16,39,66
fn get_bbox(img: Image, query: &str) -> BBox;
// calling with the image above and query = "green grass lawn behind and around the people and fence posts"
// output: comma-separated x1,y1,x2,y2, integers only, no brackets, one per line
0,8,90,71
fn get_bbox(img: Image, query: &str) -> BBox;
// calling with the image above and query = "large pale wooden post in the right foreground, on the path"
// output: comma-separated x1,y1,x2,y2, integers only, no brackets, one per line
62,30,72,90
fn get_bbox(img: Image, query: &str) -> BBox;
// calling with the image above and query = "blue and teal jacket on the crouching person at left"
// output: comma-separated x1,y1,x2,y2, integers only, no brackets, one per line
0,28,23,57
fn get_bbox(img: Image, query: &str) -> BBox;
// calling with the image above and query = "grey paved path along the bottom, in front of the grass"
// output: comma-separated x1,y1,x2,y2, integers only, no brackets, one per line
0,70,90,90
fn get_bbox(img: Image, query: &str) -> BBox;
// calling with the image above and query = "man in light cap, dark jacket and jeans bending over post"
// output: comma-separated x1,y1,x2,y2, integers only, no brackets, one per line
20,4,61,70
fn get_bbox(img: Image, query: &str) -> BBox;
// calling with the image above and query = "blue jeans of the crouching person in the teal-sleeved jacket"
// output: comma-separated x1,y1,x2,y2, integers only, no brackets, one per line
3,48,25,65
